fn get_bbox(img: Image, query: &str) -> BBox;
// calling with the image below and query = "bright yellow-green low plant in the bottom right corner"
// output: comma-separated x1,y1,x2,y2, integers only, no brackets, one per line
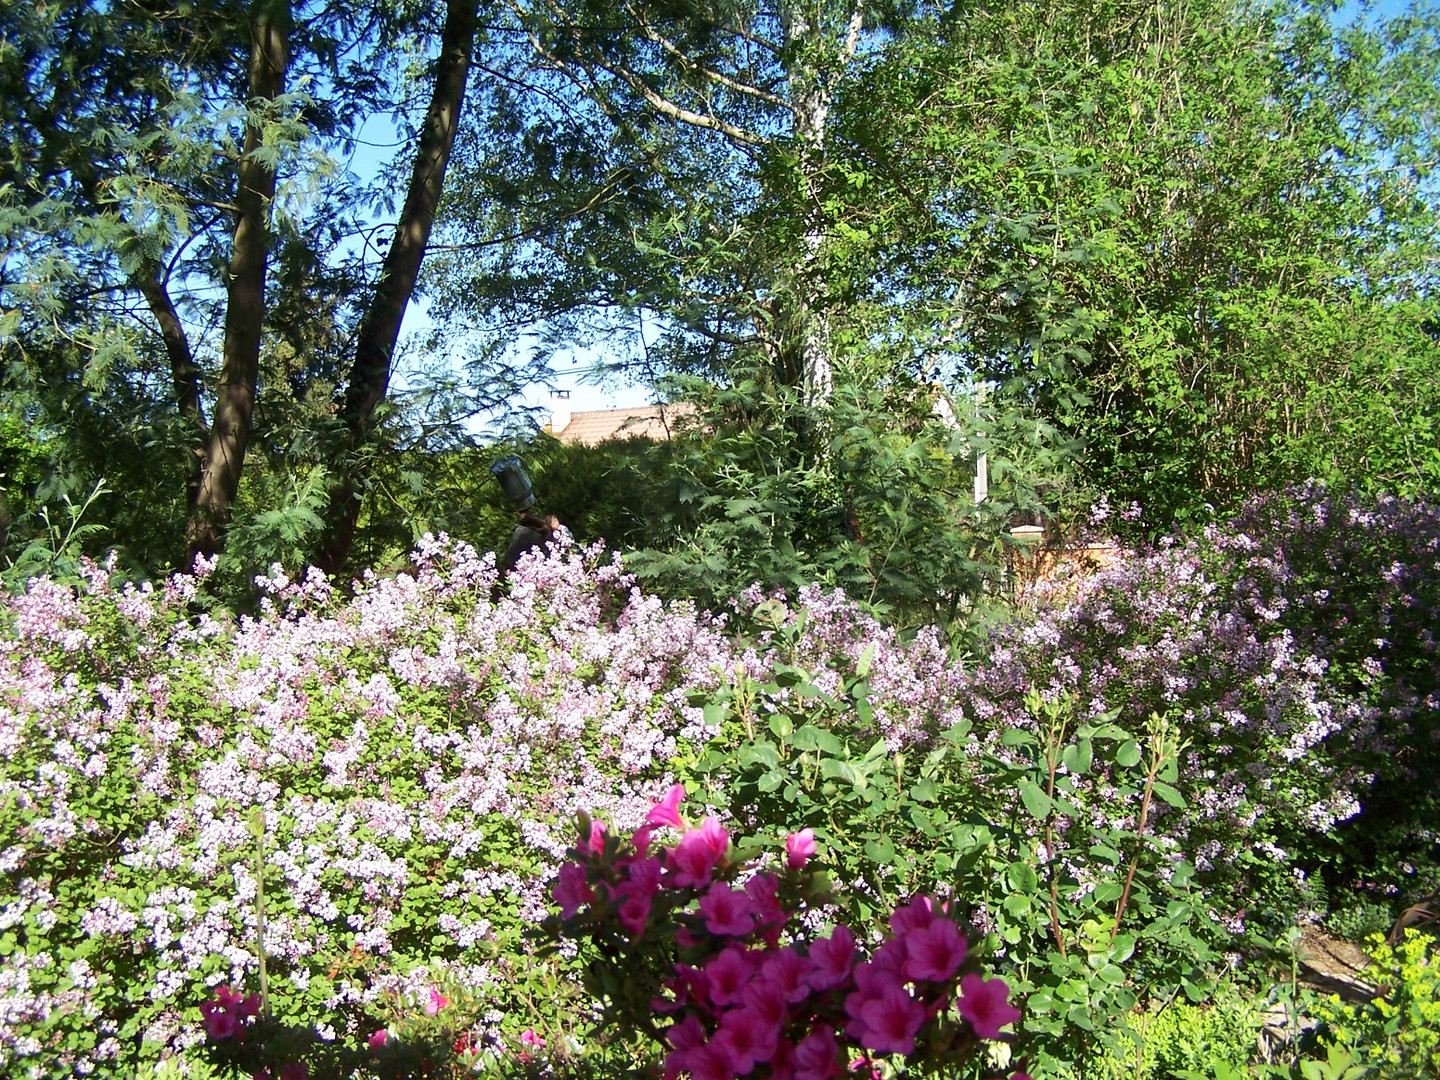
1315,930,1440,1079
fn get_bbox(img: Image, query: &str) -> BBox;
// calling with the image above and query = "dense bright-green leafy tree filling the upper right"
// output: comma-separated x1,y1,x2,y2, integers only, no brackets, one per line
837,0,1440,526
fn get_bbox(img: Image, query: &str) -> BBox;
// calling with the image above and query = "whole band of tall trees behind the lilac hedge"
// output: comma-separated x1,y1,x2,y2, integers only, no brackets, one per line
0,0,1440,613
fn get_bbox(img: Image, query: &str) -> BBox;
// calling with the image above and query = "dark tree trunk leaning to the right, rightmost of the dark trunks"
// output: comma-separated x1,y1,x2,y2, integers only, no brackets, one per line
315,0,478,573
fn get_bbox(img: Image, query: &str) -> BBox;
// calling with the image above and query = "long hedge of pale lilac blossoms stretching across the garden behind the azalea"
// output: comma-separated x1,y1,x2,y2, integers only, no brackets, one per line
0,490,1440,1076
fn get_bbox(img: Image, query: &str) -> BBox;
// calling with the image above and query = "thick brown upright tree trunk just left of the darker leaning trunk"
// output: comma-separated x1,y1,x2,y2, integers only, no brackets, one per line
186,0,289,560
